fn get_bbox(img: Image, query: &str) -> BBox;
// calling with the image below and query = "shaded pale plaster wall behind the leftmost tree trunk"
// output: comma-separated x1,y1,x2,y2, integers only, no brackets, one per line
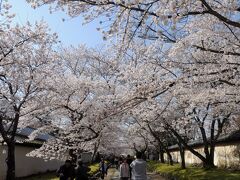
0,145,63,180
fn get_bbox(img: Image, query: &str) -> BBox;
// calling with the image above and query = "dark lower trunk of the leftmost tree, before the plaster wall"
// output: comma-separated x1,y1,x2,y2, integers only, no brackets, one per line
6,142,15,180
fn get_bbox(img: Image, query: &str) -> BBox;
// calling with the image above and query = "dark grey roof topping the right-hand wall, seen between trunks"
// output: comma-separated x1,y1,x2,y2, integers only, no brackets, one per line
168,130,240,151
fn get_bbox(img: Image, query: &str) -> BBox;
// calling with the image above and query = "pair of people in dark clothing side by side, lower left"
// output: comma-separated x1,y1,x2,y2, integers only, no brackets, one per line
57,160,90,180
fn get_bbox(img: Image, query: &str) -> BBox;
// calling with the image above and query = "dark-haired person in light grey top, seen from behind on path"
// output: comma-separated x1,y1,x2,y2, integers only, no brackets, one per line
130,152,147,180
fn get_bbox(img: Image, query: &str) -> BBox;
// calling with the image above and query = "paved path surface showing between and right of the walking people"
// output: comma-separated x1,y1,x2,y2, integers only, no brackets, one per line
104,168,165,180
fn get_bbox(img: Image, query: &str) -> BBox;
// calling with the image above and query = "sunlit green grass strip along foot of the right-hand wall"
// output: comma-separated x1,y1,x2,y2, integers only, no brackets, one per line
148,161,240,180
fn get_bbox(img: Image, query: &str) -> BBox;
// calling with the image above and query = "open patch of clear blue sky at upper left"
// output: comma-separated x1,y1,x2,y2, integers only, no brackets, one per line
8,0,103,47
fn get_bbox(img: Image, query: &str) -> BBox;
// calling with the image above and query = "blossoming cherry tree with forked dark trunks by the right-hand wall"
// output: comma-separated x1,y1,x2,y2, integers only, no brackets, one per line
165,11,239,166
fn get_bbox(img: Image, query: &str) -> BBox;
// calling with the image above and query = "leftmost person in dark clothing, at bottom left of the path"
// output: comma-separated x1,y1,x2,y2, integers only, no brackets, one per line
57,160,75,180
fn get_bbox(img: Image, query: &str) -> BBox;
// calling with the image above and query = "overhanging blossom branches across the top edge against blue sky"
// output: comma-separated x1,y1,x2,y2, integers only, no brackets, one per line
27,0,240,43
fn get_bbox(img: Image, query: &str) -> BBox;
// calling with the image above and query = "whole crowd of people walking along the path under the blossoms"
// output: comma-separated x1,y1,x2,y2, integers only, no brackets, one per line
57,152,147,180
